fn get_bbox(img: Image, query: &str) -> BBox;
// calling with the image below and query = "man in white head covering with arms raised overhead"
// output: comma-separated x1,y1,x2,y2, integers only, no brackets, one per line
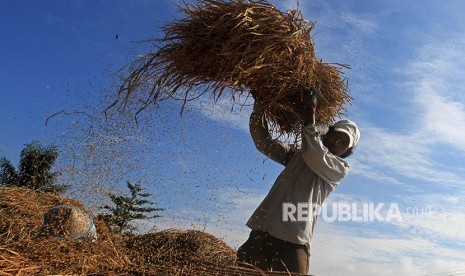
237,92,360,274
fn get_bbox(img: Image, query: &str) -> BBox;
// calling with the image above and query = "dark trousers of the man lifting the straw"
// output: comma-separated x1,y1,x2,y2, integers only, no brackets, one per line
237,230,310,275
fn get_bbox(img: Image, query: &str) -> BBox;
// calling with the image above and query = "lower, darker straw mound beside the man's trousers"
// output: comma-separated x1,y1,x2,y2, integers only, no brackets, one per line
126,229,304,276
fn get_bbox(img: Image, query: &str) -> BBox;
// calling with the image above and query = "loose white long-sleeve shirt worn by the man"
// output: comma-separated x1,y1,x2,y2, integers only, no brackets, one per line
247,111,349,252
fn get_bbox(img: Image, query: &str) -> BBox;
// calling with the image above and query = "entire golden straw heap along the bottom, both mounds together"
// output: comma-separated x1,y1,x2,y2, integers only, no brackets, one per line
0,187,300,276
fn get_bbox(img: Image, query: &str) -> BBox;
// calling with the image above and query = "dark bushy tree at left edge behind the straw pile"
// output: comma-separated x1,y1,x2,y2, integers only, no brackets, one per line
0,141,67,194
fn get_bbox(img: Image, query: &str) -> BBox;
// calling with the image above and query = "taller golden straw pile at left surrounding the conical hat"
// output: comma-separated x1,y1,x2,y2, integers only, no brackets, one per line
0,187,130,275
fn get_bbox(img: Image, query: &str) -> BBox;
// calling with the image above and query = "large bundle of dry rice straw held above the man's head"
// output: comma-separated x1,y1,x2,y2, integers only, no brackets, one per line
109,0,350,139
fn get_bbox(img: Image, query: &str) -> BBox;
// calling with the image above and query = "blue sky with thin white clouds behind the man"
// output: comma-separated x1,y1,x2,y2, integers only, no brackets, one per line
0,0,465,275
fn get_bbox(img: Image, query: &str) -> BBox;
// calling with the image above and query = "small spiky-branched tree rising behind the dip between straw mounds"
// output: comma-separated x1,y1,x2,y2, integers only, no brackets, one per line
98,181,165,235
